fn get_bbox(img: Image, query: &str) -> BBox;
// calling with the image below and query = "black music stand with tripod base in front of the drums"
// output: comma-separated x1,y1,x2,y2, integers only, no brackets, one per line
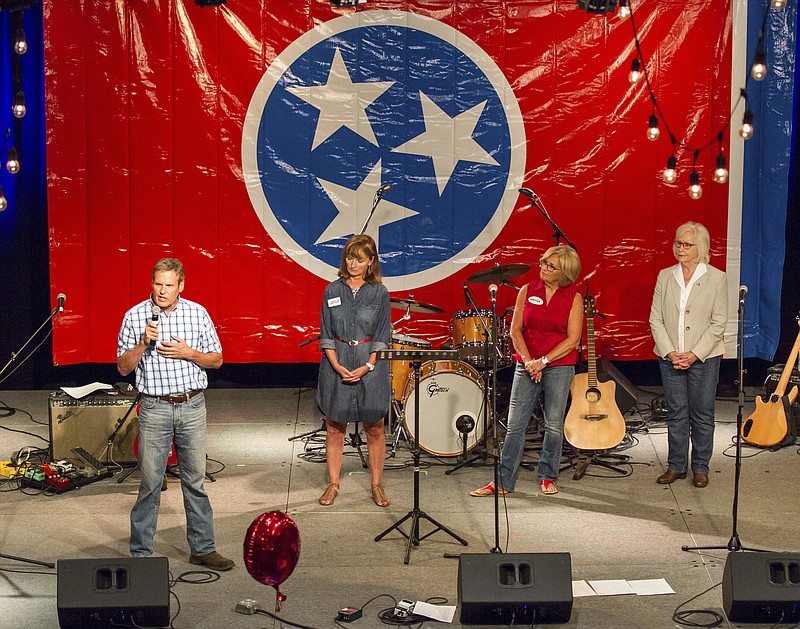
375,349,468,564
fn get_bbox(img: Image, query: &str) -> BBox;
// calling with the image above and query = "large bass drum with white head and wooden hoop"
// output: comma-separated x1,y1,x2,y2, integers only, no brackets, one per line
403,360,484,456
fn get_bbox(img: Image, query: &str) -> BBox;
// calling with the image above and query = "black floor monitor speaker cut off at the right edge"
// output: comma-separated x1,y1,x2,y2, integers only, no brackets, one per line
722,552,800,623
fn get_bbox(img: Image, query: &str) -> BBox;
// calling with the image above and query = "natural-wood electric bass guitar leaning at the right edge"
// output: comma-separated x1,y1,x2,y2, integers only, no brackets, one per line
739,320,800,448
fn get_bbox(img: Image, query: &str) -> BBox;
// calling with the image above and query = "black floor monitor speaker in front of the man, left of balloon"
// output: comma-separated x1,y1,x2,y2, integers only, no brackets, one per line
57,557,169,629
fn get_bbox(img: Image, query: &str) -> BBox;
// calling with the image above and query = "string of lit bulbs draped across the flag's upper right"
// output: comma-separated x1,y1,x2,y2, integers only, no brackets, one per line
618,0,787,200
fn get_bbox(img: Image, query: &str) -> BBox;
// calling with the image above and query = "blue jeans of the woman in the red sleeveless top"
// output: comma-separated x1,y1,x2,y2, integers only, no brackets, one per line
499,363,575,492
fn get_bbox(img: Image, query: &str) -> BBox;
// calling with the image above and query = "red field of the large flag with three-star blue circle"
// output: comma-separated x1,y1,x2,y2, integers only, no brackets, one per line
44,0,740,364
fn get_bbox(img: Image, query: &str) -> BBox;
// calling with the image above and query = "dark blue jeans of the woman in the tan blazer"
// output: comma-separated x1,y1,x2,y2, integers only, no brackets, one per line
658,356,721,474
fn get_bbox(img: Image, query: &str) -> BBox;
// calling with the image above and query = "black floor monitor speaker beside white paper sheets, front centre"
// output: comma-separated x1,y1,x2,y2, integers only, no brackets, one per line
458,553,572,625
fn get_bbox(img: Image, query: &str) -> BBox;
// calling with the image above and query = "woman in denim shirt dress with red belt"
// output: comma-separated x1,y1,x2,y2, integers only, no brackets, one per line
317,234,391,507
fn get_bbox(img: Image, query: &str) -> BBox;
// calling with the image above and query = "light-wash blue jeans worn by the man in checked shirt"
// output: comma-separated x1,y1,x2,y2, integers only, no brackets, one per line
130,393,215,557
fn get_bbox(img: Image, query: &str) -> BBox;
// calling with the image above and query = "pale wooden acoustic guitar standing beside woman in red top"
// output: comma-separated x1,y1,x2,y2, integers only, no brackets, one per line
564,294,625,450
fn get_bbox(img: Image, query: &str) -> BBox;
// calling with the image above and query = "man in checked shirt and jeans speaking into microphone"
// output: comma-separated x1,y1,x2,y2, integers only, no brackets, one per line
117,258,234,570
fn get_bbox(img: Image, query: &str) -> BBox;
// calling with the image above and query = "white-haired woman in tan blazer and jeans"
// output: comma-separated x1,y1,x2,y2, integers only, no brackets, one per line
650,221,728,487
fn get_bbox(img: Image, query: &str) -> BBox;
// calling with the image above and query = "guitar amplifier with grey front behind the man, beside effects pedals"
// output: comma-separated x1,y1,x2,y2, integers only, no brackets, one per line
49,393,139,463
